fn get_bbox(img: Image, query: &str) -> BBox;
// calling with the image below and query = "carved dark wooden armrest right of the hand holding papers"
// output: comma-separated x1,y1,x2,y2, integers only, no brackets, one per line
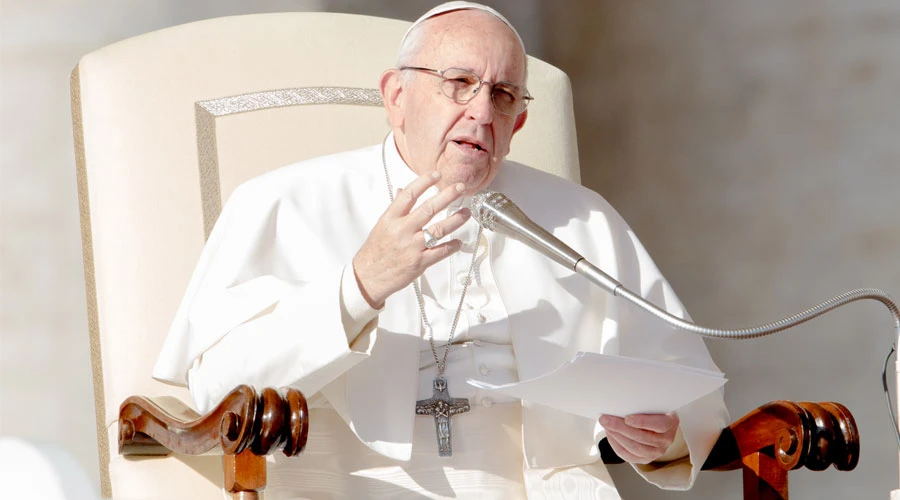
600,401,859,500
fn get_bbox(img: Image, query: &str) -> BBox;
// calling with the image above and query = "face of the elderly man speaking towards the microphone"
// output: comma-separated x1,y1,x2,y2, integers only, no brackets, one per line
392,11,525,194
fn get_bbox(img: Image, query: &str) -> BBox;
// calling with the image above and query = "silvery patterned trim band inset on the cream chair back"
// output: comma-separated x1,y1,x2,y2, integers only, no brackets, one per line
194,87,382,238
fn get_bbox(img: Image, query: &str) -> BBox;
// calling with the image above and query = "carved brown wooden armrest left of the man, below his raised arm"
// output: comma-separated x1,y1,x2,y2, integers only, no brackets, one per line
119,385,309,499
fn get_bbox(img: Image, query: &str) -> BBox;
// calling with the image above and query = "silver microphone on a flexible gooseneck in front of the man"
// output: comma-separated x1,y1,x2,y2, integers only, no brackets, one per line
465,191,900,342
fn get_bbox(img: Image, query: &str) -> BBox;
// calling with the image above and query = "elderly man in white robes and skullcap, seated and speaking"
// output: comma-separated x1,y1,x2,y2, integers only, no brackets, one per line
154,2,728,499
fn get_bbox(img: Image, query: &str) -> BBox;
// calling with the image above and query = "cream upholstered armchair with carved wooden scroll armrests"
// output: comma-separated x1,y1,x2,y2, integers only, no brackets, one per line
71,13,858,498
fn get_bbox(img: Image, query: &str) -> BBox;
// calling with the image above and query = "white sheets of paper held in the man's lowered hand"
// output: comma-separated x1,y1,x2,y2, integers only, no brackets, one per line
468,352,726,418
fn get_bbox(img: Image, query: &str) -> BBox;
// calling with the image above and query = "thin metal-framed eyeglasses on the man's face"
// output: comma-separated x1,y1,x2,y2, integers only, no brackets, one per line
400,66,534,116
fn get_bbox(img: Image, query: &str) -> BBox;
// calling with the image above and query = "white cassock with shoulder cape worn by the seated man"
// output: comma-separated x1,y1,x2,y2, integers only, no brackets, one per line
153,137,729,499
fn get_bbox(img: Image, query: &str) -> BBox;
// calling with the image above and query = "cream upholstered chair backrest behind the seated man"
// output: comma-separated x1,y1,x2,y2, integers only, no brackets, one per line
71,13,579,498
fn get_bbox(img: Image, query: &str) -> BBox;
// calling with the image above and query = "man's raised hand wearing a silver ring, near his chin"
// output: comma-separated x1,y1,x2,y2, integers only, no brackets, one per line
353,172,471,309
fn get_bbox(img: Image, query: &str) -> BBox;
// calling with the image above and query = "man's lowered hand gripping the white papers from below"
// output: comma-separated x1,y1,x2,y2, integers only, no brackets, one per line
600,413,679,464
